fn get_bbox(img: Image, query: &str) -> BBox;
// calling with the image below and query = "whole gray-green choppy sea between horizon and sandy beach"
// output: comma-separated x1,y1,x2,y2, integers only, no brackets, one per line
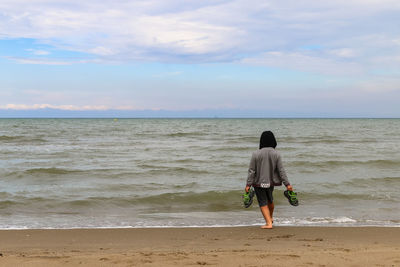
0,118,400,229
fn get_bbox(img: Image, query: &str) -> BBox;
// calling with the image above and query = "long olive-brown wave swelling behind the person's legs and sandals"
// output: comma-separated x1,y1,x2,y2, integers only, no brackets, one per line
0,187,397,215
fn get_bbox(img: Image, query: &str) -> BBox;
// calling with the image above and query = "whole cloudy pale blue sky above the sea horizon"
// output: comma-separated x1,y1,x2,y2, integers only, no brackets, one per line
0,0,400,117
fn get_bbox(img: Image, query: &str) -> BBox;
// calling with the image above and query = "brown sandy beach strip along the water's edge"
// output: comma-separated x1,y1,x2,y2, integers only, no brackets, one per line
0,227,400,266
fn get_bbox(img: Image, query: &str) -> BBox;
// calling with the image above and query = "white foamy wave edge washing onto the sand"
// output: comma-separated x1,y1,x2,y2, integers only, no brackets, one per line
0,218,400,230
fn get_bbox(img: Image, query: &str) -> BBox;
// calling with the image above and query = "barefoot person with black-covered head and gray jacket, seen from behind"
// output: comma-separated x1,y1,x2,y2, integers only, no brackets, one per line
245,131,293,229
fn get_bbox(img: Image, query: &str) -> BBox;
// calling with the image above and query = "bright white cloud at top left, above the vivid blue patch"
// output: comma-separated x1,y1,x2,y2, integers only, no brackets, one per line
0,1,245,59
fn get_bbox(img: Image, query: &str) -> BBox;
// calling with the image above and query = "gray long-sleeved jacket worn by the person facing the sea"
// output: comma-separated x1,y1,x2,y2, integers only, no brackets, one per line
247,147,290,188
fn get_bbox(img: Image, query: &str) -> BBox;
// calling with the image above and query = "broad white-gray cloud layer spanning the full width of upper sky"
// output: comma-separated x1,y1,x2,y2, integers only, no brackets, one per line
0,0,400,81
